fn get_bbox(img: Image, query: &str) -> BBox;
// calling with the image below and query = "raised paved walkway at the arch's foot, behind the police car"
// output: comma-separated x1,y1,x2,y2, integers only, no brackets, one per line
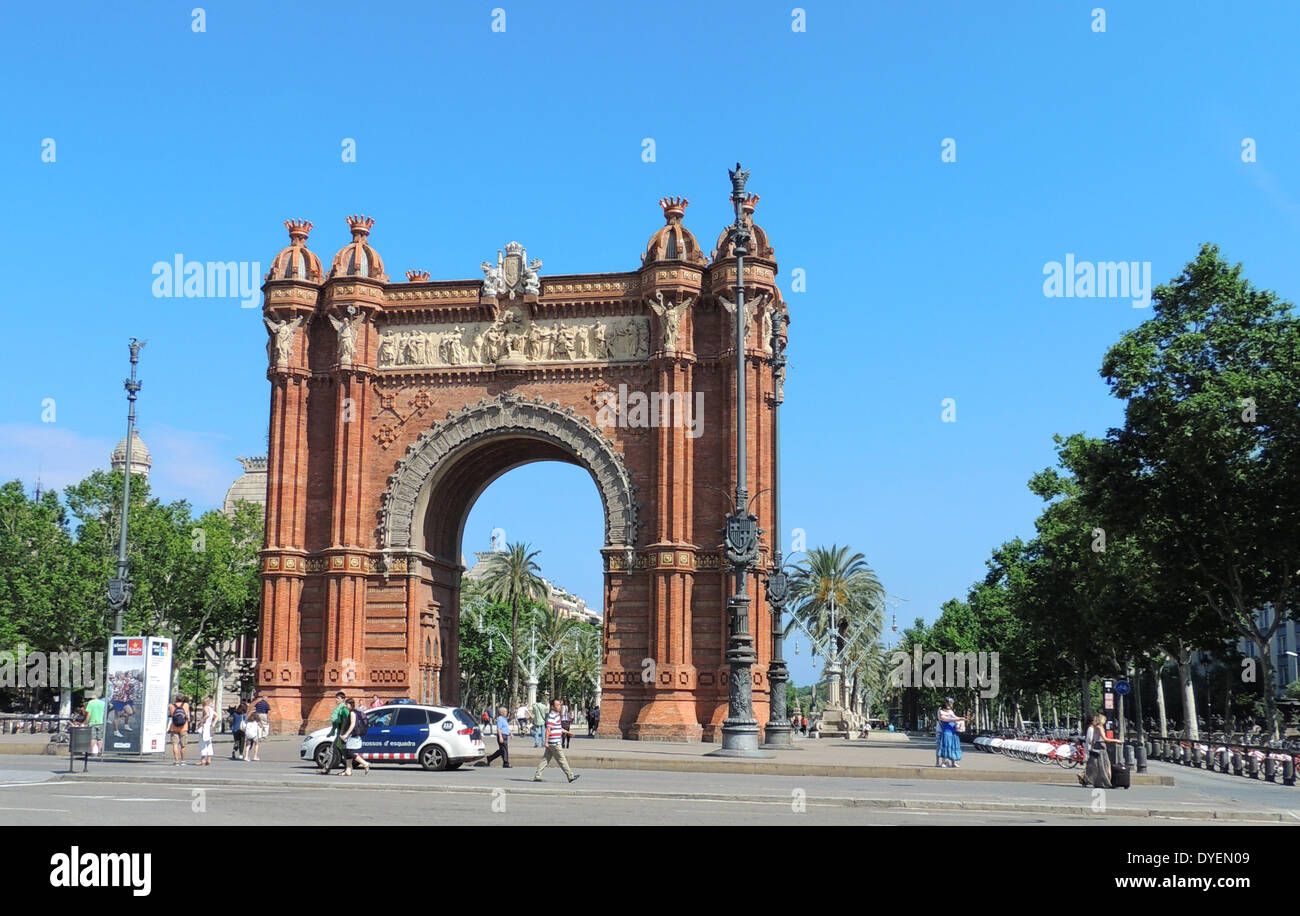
0,733,1175,786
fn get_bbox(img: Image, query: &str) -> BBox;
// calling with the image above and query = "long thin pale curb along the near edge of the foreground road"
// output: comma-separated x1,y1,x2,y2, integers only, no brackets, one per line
57,773,1296,824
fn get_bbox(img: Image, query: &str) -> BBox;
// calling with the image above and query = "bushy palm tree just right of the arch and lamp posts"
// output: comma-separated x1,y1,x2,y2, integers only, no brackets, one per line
785,544,885,689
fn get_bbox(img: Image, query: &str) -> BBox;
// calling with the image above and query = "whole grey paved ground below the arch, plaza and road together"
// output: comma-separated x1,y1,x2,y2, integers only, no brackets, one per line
0,735,1300,825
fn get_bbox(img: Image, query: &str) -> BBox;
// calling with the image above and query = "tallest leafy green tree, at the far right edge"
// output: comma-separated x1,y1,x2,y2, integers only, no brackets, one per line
1101,244,1300,733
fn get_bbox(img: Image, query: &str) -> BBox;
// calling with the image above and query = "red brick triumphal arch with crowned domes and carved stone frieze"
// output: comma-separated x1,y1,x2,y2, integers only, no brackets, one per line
257,196,787,741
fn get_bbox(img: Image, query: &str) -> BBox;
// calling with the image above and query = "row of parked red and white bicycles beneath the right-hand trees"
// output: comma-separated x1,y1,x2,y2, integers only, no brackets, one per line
974,729,1300,786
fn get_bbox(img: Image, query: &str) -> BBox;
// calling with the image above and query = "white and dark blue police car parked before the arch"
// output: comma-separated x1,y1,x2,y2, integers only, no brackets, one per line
298,702,485,769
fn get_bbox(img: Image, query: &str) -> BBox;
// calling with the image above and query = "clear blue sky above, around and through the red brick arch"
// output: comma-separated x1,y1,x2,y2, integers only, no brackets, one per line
0,0,1300,682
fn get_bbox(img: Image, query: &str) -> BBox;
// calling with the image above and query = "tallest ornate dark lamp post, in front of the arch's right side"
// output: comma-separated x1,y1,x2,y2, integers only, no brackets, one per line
712,162,768,757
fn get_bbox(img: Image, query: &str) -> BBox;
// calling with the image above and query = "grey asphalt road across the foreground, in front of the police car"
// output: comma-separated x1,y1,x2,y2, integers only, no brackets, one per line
0,755,1300,826
